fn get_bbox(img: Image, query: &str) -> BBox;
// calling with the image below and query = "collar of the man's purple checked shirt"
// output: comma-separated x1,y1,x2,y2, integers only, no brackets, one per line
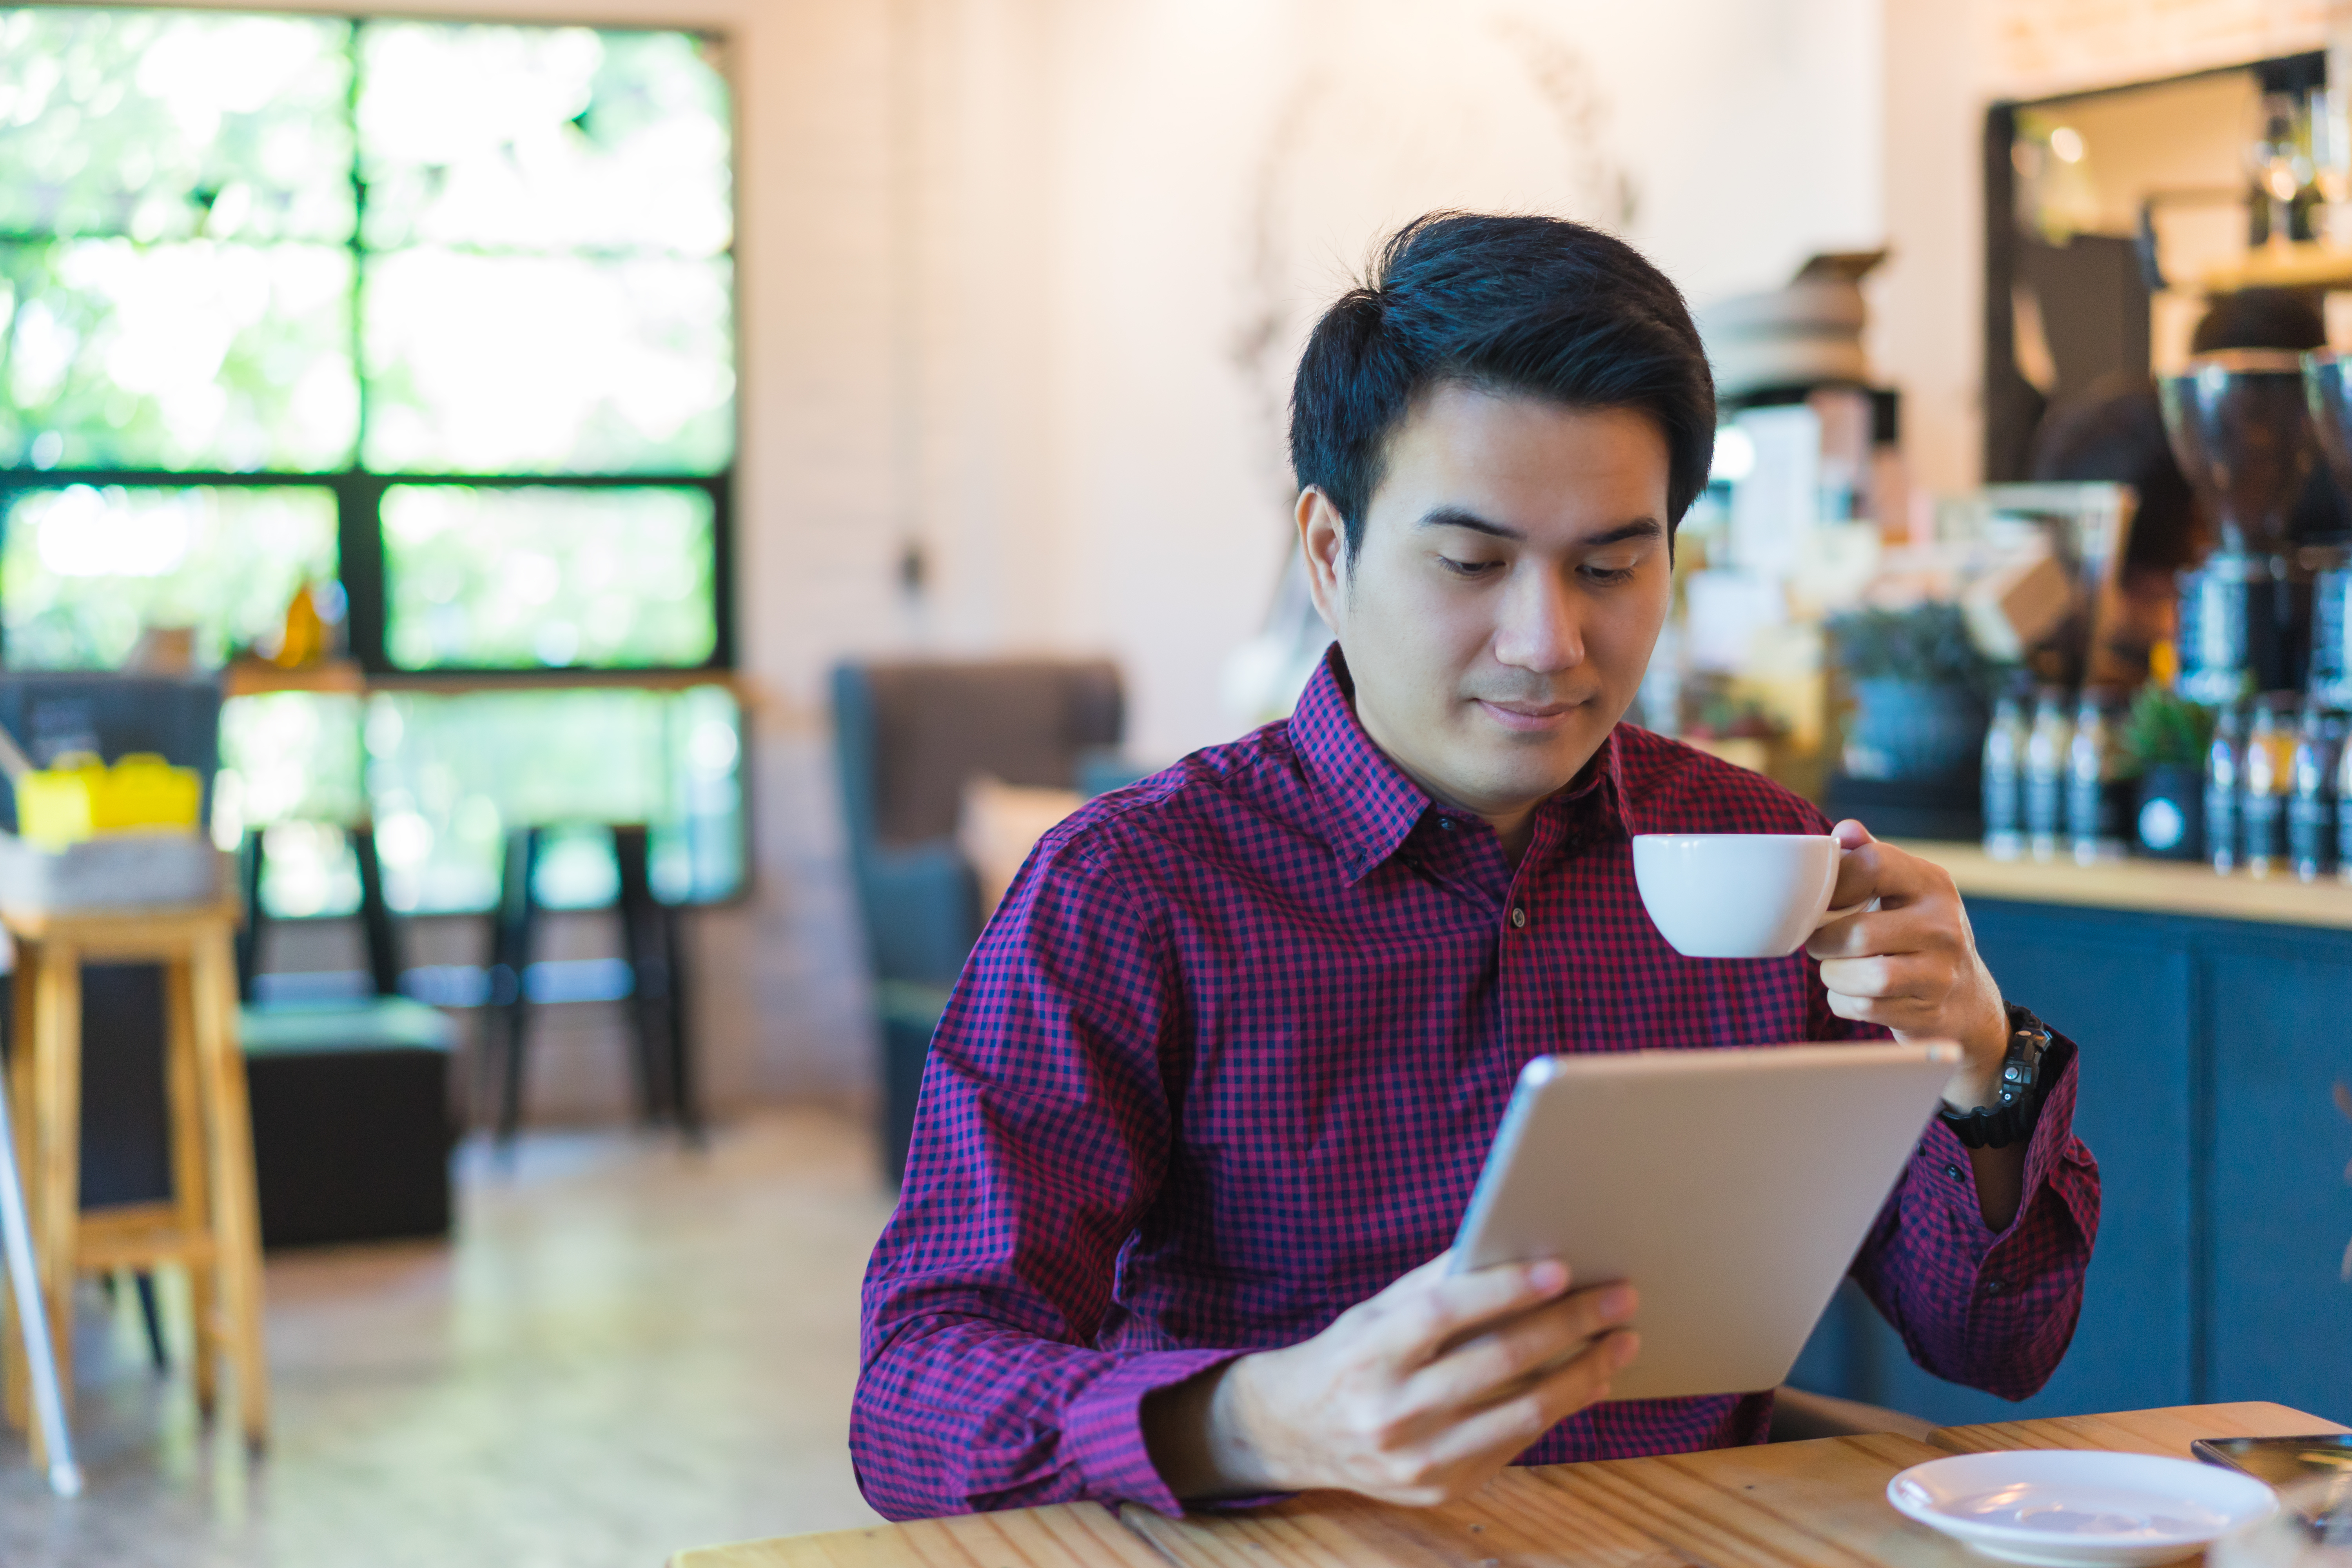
1291,642,1632,882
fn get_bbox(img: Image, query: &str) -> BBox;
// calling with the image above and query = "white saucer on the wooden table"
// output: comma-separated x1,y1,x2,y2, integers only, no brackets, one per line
1886,1448,2279,1568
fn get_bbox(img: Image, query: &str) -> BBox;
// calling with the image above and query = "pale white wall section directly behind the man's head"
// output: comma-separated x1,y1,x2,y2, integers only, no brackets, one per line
913,0,1884,757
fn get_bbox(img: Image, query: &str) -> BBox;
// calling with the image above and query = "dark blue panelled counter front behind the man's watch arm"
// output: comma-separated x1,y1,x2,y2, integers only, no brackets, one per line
1792,900,2352,1422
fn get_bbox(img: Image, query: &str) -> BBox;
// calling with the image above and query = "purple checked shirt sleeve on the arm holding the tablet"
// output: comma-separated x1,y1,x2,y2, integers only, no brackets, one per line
849,825,1232,1519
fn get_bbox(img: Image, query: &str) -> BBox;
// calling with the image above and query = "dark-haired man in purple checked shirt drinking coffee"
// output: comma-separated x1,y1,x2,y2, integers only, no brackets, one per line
849,214,2098,1519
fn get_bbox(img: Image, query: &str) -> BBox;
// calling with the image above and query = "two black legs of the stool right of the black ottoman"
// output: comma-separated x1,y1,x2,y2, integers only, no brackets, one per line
482,823,703,1145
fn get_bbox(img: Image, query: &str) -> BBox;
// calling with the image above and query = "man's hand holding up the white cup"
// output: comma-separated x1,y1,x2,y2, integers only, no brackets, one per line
1804,820,2009,1110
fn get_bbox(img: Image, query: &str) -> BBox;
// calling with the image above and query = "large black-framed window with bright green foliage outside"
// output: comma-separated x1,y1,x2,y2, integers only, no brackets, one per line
0,7,743,915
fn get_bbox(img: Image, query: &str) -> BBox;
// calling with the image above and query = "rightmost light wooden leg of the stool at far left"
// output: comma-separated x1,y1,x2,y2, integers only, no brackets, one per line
188,924,270,1453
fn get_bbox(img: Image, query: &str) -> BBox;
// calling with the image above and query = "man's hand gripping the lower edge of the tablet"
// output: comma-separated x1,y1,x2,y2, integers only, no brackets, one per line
1143,1255,1639,1507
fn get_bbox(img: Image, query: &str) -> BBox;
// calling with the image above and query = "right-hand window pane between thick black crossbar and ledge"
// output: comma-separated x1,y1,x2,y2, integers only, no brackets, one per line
383,484,717,670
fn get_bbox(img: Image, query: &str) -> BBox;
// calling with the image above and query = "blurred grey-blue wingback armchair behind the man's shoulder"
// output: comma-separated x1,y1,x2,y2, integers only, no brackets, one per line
833,661,1127,1180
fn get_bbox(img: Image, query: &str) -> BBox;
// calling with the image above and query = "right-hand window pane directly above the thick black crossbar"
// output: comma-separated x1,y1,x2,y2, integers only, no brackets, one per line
362,249,734,472
